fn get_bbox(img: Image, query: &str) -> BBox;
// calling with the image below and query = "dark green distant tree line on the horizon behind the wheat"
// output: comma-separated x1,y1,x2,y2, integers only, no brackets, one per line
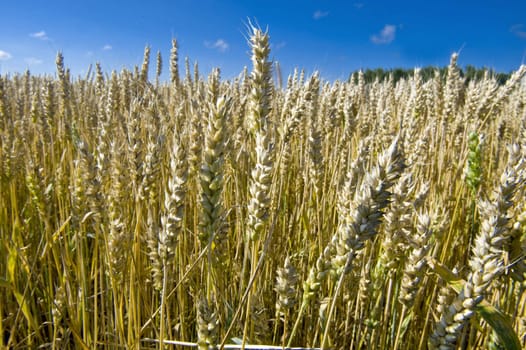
349,65,511,85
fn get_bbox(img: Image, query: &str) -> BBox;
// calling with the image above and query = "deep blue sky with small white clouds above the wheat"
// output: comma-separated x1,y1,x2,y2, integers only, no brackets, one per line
0,0,526,79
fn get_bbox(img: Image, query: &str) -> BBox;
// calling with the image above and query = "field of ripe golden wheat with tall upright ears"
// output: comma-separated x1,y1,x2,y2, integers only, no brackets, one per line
0,28,526,349
